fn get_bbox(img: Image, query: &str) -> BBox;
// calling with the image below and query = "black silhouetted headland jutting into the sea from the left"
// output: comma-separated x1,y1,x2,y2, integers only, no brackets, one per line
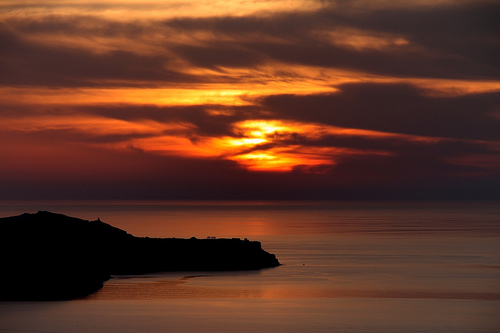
0,212,279,300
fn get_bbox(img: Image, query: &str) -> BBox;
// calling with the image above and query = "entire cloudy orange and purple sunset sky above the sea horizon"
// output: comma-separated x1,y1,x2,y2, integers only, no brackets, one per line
0,0,500,200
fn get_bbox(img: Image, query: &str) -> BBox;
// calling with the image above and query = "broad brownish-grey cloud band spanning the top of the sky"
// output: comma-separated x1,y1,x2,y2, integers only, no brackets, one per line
0,2,500,86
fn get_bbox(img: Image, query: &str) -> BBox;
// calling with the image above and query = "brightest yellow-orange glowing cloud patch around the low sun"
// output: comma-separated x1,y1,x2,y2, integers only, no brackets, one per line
112,120,394,171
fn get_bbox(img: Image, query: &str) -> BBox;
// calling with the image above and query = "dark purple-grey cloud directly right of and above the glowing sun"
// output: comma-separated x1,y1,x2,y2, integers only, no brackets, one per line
261,83,500,140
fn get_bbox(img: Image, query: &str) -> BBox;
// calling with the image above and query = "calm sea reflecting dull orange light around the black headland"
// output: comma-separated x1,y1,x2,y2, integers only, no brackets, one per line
0,201,500,333
